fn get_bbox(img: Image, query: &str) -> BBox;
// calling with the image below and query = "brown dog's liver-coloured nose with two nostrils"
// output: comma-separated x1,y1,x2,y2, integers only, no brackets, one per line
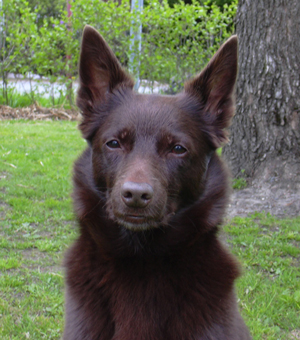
121,182,153,208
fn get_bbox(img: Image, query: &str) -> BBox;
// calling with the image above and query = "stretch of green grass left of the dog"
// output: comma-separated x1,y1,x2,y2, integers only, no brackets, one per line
0,121,85,340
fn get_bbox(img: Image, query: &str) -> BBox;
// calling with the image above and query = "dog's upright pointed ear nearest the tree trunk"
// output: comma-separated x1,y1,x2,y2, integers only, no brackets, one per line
185,35,238,148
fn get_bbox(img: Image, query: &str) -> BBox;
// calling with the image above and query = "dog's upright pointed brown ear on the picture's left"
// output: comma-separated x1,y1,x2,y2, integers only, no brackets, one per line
77,25,134,138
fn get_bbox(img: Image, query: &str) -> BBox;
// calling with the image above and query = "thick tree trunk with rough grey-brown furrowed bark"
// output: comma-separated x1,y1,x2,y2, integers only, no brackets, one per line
224,0,300,189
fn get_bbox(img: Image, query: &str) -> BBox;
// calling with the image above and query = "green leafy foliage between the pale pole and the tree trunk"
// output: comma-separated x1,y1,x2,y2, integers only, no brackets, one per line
140,1,235,91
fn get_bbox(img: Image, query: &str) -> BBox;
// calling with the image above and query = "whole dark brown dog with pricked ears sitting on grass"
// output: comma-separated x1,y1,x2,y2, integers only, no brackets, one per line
64,26,250,340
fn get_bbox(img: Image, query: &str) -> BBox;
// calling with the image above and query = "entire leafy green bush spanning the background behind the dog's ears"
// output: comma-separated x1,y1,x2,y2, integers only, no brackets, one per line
0,0,237,103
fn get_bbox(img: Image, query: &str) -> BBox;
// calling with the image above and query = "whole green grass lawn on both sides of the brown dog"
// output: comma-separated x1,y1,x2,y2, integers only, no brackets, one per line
0,121,300,340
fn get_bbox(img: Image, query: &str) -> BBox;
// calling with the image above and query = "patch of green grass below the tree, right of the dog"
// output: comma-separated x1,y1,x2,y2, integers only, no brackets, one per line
224,213,300,340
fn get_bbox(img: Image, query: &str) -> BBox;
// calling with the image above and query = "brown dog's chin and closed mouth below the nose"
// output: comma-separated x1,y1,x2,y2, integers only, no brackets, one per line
116,215,160,231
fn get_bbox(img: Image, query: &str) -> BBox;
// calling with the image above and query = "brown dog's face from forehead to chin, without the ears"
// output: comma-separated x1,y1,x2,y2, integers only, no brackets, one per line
92,90,209,229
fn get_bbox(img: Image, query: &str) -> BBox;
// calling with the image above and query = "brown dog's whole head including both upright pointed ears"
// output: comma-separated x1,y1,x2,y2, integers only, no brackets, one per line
77,27,237,230
